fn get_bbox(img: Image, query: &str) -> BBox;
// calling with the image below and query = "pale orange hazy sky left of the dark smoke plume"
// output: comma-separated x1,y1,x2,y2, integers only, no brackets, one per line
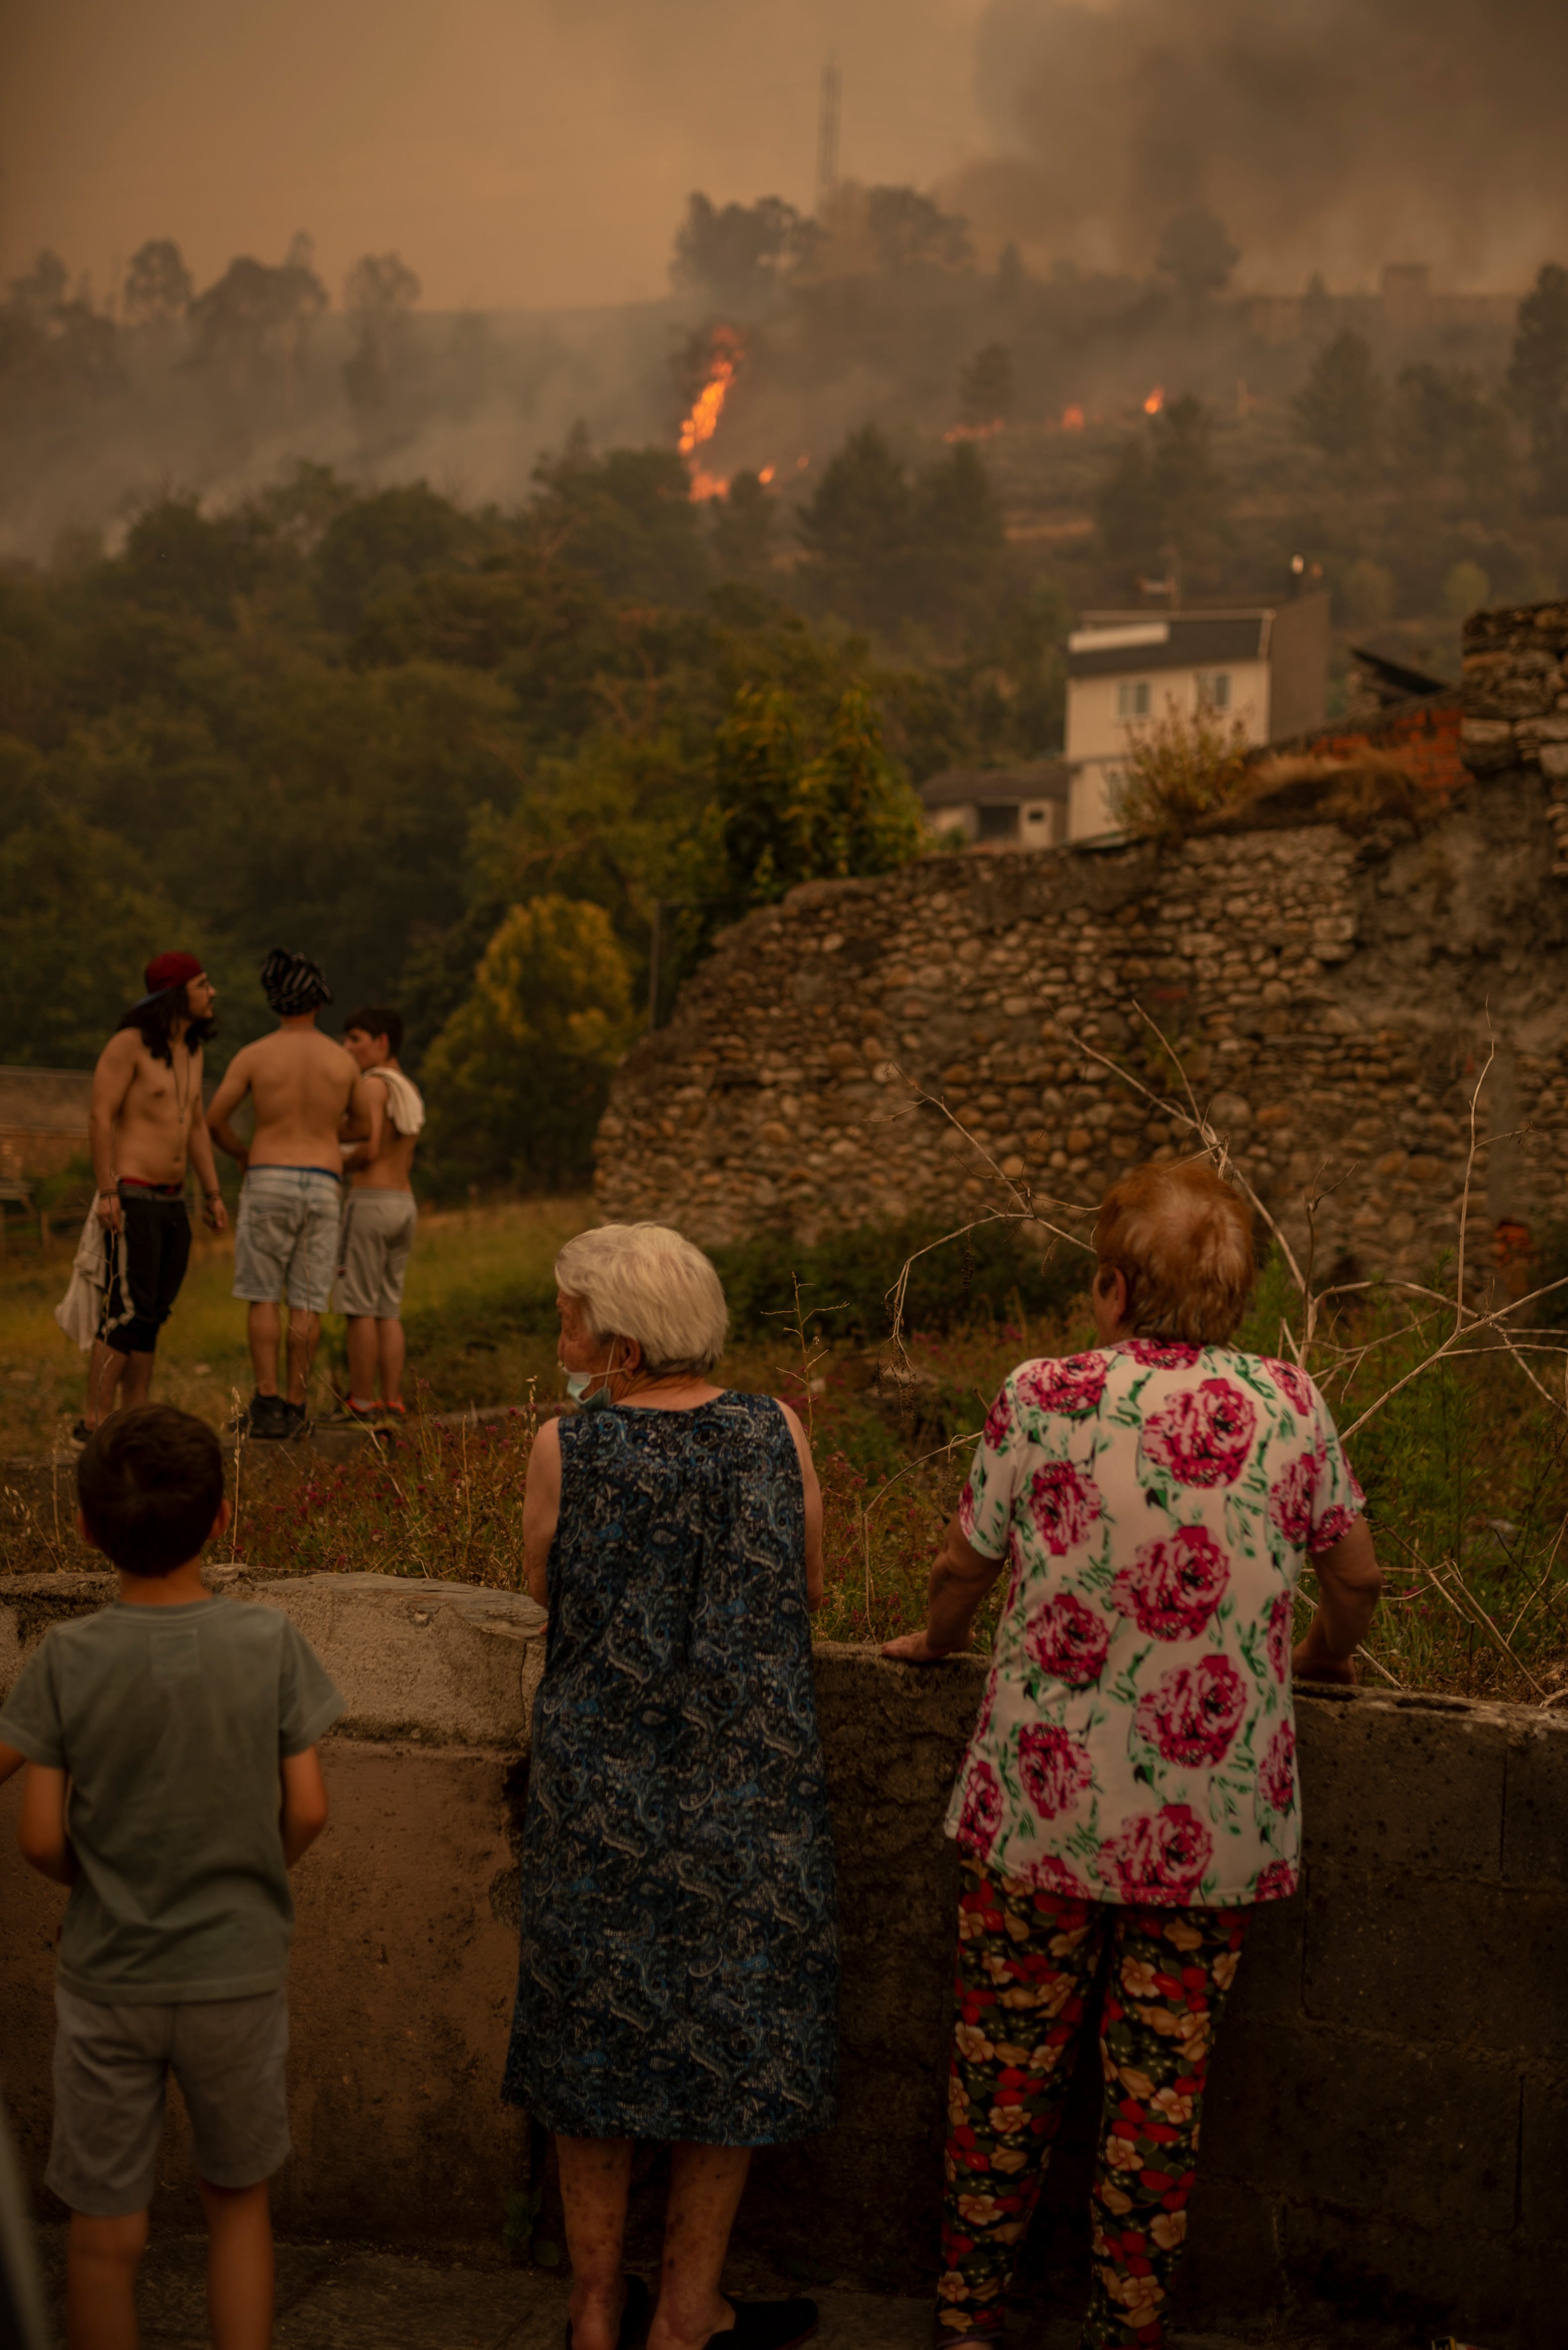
0,0,985,305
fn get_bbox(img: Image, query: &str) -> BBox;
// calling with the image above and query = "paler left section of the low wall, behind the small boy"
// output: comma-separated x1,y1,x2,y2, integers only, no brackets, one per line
0,1570,543,2244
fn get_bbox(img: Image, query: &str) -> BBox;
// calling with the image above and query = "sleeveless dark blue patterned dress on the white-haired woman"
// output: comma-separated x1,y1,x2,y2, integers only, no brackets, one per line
501,1391,839,2146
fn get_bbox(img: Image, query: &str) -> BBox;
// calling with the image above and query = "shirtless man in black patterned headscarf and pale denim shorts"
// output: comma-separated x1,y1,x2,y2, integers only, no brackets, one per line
207,947,383,1438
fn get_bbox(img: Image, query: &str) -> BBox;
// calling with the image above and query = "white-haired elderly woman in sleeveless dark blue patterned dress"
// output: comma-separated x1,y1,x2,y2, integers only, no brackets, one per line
503,1224,839,2350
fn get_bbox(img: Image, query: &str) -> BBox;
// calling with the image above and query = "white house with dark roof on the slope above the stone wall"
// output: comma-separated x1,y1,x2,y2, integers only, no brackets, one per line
1067,595,1328,841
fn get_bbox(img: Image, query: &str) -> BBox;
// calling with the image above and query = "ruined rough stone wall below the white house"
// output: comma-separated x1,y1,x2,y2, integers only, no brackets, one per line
597,606,1568,1278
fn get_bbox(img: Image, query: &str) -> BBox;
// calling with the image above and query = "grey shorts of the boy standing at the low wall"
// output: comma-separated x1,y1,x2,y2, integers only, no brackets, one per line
45,1984,289,2218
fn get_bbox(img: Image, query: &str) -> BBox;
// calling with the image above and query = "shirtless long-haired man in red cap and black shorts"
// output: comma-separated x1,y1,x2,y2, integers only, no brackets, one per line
75,954,228,1443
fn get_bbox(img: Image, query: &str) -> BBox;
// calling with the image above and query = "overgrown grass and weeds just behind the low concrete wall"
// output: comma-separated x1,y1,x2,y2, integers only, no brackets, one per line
0,1201,1568,1704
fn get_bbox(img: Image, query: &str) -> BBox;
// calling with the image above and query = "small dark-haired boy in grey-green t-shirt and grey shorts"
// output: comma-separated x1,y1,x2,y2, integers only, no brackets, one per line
0,1405,343,2350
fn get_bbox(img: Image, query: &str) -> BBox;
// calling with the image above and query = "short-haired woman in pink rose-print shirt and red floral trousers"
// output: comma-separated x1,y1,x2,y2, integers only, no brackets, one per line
886,1166,1378,2350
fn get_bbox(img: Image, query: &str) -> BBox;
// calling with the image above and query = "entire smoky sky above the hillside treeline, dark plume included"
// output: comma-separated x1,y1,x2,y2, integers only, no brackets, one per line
0,0,1568,310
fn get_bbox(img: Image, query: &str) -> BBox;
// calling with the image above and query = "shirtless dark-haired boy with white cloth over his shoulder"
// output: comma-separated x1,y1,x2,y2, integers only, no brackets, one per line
334,1003,426,1420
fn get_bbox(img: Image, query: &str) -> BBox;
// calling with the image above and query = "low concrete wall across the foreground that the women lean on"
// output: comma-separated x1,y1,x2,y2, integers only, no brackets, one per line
0,1577,1568,2350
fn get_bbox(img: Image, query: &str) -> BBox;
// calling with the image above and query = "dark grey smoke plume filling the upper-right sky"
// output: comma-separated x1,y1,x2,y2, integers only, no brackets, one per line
948,0,1568,289
